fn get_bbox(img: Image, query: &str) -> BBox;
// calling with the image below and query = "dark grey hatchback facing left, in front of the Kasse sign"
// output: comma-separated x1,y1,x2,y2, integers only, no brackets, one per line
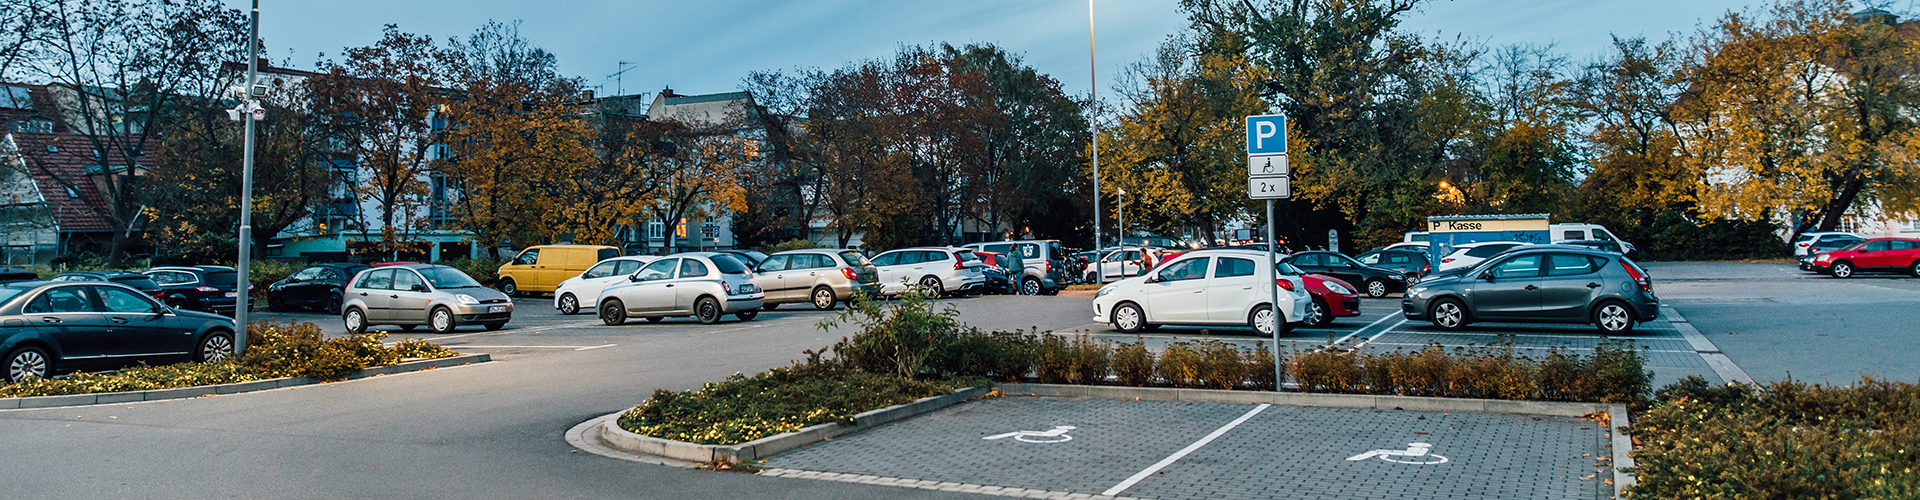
1400,244,1661,335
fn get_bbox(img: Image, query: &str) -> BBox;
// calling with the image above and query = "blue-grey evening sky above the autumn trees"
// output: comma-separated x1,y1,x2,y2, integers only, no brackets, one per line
247,0,1774,102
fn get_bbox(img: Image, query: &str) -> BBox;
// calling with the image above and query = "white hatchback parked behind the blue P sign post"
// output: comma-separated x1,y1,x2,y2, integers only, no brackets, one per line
1092,250,1313,335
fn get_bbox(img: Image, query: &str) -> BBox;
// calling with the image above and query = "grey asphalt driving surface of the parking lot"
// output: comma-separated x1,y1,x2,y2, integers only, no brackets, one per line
0,263,1920,498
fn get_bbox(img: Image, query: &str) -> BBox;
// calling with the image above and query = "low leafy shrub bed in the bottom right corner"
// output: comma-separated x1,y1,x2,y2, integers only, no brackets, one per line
1626,377,1920,498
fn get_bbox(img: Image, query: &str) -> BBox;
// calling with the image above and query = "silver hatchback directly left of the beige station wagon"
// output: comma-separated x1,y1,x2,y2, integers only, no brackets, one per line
593,252,766,325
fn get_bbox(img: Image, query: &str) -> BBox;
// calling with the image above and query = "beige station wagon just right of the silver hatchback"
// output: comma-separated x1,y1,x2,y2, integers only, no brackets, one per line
755,250,879,310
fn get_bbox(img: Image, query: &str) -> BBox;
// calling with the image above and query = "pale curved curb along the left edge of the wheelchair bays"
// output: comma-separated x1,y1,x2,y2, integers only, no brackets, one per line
599,387,987,462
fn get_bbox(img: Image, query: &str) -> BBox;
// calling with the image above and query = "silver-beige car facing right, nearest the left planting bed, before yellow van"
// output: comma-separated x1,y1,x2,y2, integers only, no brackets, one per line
340,263,513,333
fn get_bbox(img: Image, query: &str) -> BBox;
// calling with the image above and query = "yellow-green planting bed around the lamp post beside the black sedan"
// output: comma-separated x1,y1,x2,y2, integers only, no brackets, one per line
0,321,459,398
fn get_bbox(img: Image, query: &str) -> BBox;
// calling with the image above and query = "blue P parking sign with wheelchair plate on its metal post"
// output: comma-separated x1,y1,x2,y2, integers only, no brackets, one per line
1246,115,1292,382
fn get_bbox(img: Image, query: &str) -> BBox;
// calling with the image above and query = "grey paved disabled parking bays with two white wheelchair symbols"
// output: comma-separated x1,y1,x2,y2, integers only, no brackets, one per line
762,396,1613,500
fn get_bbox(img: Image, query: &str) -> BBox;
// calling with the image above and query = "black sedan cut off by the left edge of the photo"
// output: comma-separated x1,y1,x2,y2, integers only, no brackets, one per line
0,281,234,383
